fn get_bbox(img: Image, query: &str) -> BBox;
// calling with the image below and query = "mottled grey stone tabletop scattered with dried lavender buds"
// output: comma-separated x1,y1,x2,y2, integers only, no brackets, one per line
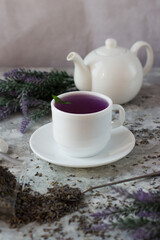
0,69,160,240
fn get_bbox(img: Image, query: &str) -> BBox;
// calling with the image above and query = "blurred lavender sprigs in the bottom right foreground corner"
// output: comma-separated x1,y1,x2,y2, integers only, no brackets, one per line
80,188,160,240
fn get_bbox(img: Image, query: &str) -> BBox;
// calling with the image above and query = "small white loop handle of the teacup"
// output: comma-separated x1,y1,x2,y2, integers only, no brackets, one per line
112,104,125,128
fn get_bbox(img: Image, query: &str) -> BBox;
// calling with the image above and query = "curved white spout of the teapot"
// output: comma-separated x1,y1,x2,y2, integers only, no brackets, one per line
67,52,91,91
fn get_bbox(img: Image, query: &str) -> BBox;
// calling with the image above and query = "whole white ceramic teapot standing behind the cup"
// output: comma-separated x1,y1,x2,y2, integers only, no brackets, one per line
67,39,153,104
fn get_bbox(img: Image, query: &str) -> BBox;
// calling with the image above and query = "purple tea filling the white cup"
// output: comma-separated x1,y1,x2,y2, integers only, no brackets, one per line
55,94,109,114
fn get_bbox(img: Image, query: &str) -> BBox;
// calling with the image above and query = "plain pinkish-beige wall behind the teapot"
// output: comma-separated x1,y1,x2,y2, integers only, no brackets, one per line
0,0,160,69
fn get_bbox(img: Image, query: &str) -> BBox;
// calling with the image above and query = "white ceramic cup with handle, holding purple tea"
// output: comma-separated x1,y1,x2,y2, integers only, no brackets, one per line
51,91,125,157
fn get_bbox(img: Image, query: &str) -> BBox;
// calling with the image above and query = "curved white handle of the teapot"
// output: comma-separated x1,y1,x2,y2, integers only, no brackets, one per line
130,41,154,75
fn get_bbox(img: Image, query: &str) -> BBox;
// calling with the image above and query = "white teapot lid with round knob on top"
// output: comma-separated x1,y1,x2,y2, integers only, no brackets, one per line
95,38,127,56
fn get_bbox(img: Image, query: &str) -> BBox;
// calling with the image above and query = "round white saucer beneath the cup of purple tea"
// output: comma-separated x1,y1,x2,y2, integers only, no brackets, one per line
29,123,135,168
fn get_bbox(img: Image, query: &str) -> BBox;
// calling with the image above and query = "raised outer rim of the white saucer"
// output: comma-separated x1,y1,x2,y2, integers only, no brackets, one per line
29,122,136,168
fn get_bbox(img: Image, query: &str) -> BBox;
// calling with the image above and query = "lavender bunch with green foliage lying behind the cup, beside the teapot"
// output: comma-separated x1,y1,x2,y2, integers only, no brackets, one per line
0,68,76,133
